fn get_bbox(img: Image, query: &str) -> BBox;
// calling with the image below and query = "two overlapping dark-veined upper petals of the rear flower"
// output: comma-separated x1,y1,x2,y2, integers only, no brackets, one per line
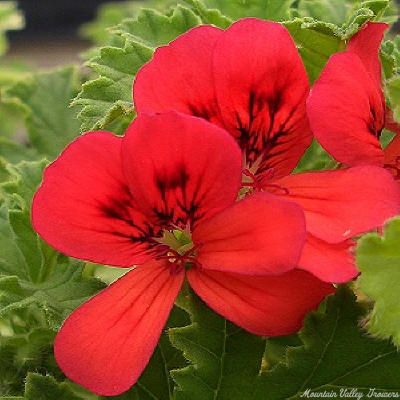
134,18,311,176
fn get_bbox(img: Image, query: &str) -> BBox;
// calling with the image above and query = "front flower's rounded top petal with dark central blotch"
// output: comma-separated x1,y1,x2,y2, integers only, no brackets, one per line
122,112,241,226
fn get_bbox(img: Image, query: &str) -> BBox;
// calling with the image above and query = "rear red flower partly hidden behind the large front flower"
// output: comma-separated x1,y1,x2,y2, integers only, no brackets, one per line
133,18,400,282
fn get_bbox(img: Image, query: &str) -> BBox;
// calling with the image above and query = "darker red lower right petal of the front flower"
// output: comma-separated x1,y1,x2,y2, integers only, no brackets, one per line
187,269,334,336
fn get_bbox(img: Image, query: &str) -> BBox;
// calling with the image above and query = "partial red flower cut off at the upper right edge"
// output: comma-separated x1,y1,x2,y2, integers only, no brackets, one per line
307,22,400,170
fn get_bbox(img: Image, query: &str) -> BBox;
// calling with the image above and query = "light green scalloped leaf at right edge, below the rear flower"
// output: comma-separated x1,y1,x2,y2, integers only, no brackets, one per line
357,218,400,347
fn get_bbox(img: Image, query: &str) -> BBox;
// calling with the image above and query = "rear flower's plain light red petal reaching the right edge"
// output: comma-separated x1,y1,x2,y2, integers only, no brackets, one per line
267,166,400,243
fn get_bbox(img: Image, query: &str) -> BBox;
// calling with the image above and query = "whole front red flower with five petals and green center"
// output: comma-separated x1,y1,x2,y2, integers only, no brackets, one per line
32,112,333,395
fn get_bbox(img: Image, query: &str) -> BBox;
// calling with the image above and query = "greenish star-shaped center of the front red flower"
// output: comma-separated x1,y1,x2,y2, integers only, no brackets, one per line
155,226,199,274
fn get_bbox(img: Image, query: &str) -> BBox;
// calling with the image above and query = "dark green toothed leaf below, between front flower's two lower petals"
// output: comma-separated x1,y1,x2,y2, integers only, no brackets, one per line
169,293,265,400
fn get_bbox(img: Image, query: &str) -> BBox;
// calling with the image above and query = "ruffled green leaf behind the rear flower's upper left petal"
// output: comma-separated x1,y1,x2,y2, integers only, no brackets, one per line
73,6,201,133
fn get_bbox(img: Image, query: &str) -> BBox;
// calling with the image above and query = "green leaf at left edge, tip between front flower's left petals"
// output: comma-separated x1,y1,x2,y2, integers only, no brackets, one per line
0,161,104,329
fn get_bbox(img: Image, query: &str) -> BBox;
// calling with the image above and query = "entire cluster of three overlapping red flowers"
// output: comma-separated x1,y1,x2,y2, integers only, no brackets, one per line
32,18,400,395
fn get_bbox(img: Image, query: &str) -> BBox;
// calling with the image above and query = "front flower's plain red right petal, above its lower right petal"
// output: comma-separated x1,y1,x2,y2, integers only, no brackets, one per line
193,193,305,275
